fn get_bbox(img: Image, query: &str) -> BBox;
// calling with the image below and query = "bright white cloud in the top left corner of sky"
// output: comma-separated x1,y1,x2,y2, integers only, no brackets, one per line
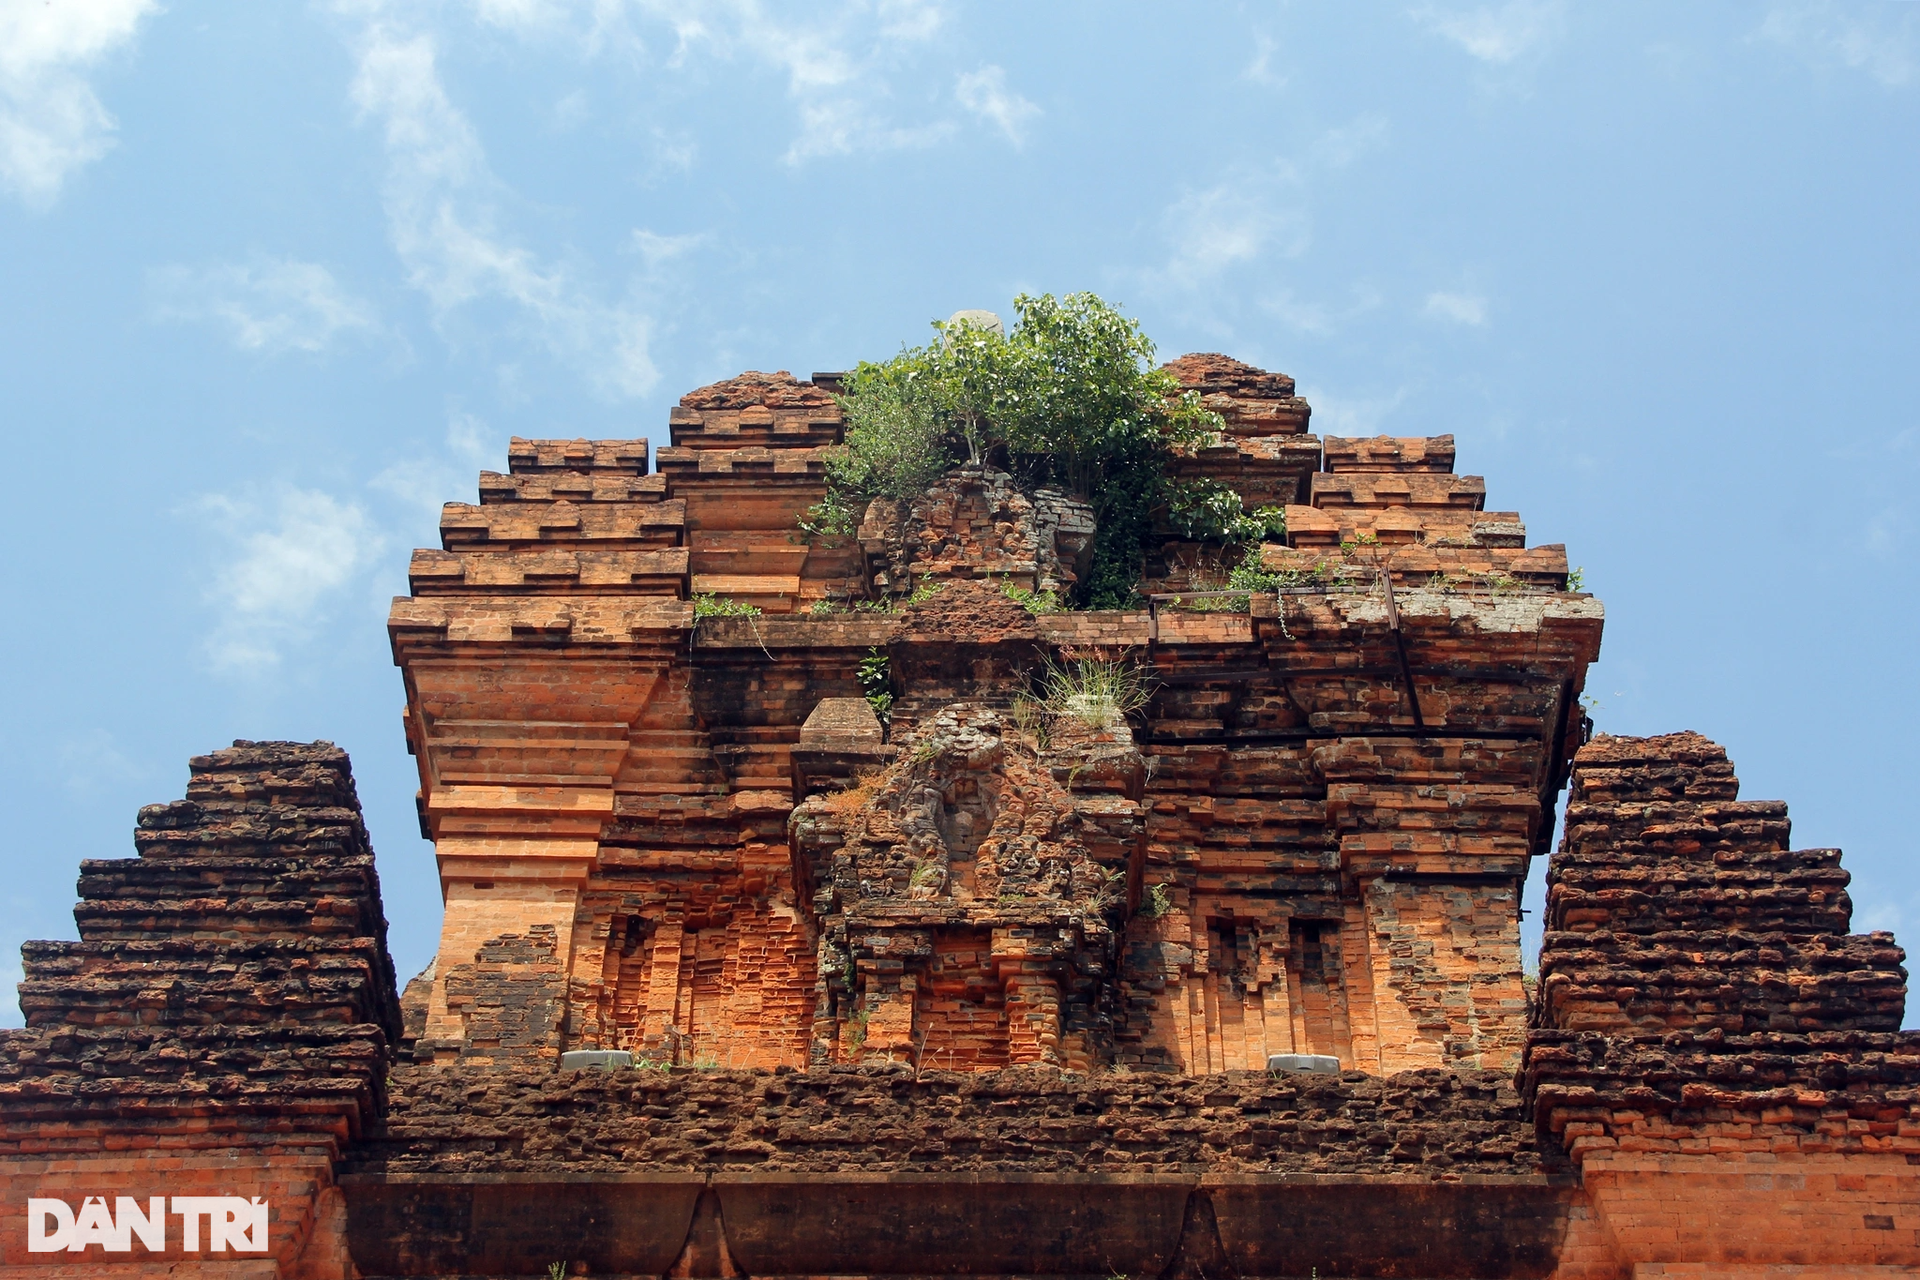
0,0,159,207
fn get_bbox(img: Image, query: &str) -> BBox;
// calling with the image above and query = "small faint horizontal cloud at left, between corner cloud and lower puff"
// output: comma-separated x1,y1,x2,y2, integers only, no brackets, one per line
148,257,380,353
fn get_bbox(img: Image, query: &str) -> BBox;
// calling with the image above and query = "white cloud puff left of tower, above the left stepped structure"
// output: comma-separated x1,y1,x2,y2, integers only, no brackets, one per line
200,487,384,672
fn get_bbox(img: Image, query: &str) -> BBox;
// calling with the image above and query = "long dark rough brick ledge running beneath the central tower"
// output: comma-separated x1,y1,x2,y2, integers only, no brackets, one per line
344,1065,1565,1178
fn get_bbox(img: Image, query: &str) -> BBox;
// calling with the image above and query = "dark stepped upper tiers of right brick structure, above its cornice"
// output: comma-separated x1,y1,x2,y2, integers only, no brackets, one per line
1538,733,1907,1036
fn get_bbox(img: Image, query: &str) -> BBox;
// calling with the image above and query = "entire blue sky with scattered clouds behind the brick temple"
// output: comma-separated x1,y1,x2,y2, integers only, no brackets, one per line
0,0,1920,1025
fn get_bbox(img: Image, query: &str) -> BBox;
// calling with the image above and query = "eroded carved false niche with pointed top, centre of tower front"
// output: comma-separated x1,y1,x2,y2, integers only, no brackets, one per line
791,704,1140,1069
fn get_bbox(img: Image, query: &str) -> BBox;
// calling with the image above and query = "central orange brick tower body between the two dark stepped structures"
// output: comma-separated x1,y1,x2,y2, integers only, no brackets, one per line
392,357,1599,1073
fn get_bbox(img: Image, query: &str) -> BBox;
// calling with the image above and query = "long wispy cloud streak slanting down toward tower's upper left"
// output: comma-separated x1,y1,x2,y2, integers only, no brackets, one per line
351,21,659,397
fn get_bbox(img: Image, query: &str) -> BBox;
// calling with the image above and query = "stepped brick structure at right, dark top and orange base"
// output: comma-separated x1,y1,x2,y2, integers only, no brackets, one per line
1521,733,1920,1274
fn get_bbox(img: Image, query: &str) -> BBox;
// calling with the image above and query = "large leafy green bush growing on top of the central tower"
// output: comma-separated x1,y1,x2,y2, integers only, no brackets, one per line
801,294,1279,608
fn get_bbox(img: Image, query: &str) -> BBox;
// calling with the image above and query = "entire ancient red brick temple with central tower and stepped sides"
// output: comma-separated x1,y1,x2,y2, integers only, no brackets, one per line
0,355,1920,1280
